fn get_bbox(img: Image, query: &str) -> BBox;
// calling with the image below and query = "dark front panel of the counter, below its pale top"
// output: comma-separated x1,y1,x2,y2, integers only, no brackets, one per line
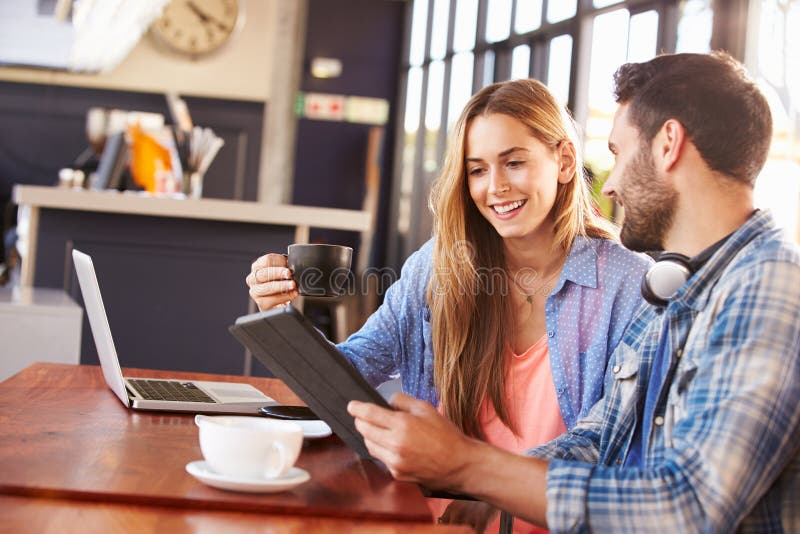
32,208,294,375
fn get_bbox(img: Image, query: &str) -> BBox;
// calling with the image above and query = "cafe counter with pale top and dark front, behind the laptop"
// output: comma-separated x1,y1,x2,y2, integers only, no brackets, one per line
13,186,371,375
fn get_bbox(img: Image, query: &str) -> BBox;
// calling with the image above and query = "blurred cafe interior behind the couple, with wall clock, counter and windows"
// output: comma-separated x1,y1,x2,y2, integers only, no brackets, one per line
0,0,800,386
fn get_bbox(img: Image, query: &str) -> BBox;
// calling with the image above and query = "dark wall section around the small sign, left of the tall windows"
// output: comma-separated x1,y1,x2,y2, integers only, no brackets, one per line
292,0,406,265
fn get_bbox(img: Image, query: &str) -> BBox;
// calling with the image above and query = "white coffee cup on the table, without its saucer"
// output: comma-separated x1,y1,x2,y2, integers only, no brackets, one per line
194,415,303,478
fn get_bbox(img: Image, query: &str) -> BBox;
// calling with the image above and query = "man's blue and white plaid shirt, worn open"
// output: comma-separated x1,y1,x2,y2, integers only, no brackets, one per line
529,212,800,533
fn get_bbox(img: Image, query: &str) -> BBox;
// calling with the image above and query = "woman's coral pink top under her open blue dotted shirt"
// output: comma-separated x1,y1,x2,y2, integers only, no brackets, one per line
430,335,567,533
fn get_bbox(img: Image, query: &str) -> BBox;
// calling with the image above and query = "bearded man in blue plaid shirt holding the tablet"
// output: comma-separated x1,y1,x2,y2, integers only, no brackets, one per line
350,53,800,532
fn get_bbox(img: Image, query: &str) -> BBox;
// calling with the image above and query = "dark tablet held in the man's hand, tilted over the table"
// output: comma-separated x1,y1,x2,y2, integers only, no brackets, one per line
229,306,392,458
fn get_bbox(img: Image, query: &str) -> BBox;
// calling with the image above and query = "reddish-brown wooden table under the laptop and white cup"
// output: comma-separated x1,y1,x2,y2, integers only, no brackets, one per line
0,363,468,532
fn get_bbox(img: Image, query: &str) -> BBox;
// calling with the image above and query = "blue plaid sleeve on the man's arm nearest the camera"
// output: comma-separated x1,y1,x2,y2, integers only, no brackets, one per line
532,259,800,533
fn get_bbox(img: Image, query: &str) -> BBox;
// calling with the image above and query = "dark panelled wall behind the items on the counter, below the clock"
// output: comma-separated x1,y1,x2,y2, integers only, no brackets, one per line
0,82,264,202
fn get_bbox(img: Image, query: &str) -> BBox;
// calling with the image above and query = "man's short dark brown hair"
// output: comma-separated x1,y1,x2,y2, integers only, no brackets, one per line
614,52,772,186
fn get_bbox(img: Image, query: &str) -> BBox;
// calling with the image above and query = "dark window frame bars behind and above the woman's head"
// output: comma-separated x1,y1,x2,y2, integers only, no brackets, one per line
387,0,696,267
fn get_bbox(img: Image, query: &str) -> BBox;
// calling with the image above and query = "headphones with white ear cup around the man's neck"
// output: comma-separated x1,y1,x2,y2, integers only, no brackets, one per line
642,235,730,308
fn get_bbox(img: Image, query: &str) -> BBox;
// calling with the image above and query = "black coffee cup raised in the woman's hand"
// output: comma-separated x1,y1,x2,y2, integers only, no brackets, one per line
288,243,353,297
